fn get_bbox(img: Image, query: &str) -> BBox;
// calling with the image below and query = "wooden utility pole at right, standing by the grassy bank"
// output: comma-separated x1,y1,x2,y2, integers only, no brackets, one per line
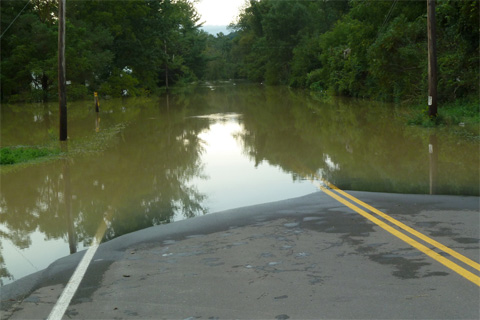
427,0,437,117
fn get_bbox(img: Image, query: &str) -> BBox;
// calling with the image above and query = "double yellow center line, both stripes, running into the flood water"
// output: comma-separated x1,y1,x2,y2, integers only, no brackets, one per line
312,177,480,286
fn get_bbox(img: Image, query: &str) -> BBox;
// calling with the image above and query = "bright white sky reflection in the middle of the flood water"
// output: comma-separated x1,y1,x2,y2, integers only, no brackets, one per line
184,115,317,220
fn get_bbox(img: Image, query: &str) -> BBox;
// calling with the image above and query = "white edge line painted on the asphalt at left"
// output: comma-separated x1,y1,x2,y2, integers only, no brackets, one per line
47,241,99,320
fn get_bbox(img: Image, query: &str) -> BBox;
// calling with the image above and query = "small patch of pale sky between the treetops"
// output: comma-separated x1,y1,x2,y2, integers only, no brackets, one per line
195,0,245,26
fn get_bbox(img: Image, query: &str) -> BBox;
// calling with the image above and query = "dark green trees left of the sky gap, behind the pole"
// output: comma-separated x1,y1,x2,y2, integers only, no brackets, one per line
1,0,207,101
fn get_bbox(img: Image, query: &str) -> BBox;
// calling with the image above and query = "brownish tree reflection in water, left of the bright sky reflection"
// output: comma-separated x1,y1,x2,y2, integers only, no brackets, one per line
0,101,208,279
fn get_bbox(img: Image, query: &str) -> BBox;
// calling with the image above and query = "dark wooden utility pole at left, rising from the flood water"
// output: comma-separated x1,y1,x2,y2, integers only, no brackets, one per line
58,0,67,141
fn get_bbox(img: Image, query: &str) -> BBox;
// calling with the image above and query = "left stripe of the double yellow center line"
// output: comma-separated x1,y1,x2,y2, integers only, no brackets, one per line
317,184,480,286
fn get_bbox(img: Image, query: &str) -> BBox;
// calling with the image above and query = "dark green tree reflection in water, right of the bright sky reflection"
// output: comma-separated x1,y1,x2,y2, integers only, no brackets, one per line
237,88,479,195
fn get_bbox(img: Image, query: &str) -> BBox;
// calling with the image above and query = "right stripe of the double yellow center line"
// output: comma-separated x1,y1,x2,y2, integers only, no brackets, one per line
321,179,480,271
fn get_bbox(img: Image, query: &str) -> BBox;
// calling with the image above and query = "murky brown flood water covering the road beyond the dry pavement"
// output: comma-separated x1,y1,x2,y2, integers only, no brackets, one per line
0,83,479,284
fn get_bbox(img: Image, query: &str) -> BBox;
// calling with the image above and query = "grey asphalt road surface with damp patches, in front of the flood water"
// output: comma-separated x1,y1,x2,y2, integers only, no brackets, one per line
1,192,480,319
